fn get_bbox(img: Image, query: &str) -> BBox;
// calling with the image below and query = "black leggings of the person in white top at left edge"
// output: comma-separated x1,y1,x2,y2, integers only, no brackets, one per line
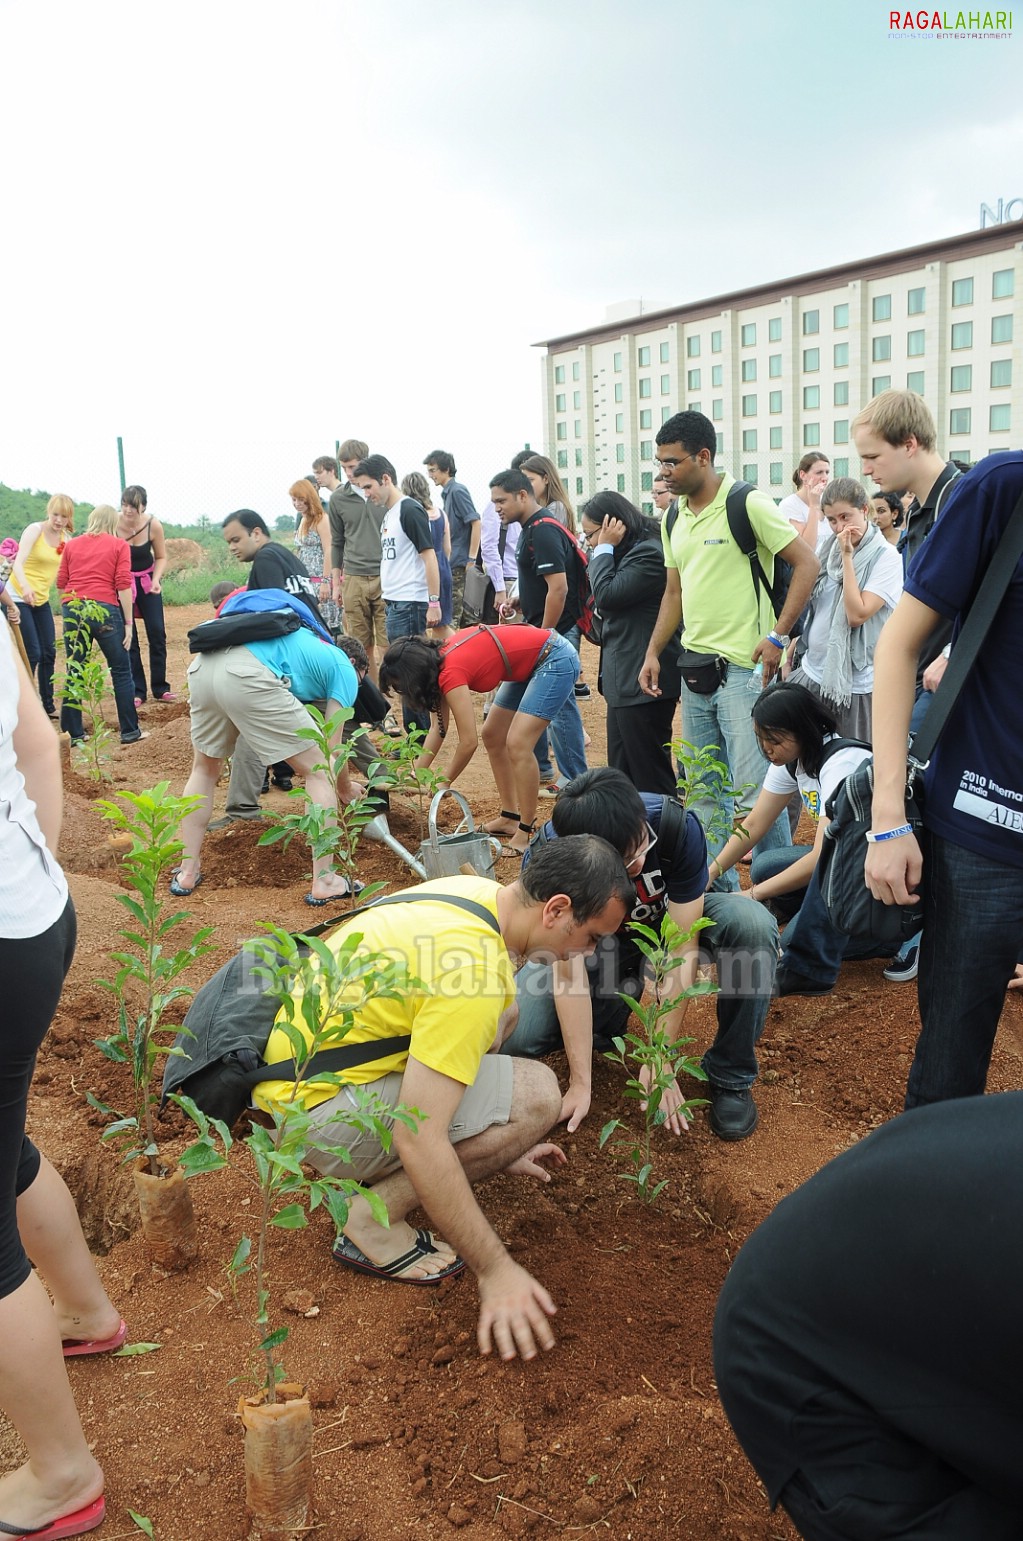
0,897,77,1299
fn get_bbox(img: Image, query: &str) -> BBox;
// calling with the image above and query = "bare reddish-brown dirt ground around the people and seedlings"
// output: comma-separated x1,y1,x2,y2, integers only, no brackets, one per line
10,609,1023,1541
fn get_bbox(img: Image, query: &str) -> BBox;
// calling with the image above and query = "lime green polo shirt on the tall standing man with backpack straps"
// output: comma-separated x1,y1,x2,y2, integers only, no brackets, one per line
661,475,798,669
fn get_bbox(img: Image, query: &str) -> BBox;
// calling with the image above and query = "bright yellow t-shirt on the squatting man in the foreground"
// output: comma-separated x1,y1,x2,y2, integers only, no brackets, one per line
253,877,515,1113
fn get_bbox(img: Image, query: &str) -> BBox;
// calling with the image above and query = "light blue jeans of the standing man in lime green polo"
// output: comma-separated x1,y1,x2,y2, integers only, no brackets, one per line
683,664,790,894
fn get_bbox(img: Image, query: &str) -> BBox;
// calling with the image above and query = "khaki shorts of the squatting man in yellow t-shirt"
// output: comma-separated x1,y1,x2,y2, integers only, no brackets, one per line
307,1054,515,1183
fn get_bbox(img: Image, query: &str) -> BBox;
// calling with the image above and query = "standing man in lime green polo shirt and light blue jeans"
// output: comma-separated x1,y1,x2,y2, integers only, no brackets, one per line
639,411,820,888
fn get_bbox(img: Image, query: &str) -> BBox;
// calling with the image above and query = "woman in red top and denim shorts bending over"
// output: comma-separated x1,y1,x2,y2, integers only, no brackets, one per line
381,626,579,857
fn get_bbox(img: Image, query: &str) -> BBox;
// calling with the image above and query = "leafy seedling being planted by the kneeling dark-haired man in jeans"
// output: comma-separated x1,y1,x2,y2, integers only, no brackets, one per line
599,914,718,1204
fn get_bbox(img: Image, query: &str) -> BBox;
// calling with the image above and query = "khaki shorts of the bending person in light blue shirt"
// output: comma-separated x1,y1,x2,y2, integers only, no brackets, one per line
188,647,310,766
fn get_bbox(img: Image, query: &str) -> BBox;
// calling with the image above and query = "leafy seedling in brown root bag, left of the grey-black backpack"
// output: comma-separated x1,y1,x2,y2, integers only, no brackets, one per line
86,781,213,1268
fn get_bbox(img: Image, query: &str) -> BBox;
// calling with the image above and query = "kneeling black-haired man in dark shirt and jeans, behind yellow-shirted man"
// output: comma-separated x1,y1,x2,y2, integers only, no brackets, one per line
504,767,778,1140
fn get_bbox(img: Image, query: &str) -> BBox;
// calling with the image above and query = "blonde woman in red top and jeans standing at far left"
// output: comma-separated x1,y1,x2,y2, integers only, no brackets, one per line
57,504,146,744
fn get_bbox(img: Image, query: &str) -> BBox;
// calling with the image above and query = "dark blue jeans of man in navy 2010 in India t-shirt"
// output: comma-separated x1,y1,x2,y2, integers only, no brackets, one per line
906,832,1023,1108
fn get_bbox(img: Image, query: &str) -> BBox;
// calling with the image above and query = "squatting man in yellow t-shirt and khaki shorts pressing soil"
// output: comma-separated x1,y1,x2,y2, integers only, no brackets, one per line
256,835,635,1359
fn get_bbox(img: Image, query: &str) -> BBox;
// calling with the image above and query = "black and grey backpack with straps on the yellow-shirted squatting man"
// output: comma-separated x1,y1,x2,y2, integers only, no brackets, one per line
160,891,501,1128
